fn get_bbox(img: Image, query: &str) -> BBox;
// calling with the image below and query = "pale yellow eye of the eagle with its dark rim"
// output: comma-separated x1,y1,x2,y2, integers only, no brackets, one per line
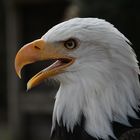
64,39,77,50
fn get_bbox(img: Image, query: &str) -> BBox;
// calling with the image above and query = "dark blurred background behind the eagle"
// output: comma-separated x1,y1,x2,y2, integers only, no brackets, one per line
0,0,140,140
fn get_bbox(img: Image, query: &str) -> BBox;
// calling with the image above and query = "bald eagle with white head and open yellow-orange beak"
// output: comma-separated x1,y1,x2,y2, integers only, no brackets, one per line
15,18,140,140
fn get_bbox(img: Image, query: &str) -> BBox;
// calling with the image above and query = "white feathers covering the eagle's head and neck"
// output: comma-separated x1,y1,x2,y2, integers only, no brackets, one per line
42,18,140,140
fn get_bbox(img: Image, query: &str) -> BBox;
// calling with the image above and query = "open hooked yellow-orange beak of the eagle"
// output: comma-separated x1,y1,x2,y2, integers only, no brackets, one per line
15,39,75,90
